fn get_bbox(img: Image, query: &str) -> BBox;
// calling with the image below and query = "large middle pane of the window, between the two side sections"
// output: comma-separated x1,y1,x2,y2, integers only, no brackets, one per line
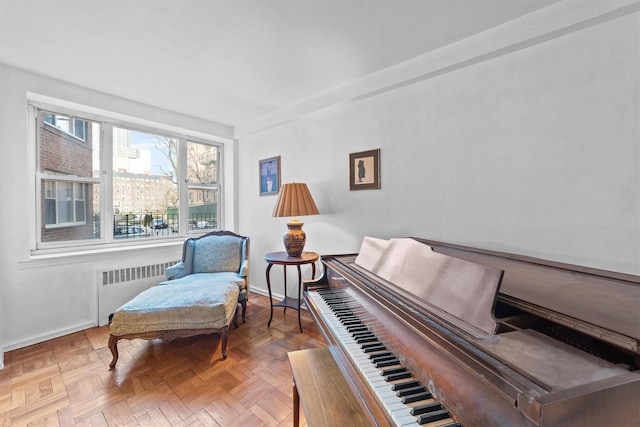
113,127,178,238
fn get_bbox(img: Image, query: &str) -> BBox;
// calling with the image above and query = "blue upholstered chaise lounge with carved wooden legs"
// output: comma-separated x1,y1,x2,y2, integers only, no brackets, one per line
109,231,249,368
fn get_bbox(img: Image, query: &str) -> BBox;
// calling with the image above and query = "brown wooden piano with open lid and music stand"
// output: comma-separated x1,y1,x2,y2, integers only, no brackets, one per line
303,237,640,427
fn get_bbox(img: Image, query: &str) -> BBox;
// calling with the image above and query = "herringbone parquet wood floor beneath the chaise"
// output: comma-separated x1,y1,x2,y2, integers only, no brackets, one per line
0,294,325,427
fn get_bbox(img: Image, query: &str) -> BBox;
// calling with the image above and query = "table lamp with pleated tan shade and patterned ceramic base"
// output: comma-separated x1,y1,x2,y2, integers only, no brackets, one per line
273,182,320,257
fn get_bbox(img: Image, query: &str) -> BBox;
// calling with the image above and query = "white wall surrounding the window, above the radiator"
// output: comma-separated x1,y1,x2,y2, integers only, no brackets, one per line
0,65,237,361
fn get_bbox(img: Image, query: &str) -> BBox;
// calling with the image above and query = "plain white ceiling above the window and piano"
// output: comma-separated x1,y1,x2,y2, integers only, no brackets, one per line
0,0,560,126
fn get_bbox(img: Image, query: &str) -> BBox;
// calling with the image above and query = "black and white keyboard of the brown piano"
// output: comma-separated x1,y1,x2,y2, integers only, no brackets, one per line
308,289,461,427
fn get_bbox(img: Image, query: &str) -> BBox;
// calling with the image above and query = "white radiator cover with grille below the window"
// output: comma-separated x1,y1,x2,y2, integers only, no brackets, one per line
96,261,178,326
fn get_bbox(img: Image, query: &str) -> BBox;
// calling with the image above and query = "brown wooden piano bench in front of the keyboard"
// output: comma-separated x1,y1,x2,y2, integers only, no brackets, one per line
287,347,373,427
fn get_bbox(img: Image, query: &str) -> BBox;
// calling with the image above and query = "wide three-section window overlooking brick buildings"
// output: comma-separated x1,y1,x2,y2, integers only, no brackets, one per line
30,106,222,249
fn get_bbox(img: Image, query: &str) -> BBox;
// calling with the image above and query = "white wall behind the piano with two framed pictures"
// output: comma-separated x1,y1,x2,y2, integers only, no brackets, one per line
237,1,640,300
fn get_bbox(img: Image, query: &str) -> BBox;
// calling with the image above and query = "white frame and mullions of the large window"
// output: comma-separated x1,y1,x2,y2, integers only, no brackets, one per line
28,100,233,255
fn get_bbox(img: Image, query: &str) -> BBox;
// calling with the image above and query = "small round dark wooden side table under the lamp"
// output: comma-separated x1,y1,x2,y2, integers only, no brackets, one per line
264,252,320,332
